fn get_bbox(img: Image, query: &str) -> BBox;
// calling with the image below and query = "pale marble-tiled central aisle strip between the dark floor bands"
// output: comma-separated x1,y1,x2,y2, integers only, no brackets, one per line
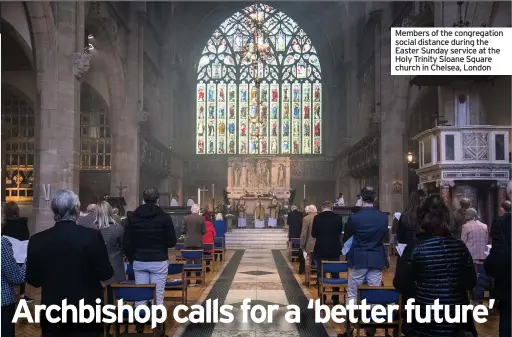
212,249,298,337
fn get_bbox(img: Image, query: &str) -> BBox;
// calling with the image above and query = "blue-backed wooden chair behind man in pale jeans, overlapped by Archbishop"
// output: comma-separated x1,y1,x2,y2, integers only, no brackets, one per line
110,283,159,337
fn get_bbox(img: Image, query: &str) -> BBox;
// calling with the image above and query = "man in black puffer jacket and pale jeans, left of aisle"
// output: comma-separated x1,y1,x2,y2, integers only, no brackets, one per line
124,188,176,304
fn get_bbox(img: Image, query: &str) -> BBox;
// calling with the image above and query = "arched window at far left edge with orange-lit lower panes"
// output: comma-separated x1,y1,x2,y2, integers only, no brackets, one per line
2,87,35,202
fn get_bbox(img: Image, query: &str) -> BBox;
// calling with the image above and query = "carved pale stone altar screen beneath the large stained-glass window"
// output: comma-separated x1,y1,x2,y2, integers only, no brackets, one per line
227,156,290,217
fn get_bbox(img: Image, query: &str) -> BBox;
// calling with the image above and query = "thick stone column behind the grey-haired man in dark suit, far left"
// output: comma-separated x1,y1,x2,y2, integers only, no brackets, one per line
30,2,83,234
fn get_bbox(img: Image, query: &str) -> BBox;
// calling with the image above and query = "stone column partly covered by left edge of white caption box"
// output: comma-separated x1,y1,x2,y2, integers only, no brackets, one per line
375,7,409,221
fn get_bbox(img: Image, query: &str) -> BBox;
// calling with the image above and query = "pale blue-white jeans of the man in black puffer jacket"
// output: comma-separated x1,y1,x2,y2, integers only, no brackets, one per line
133,261,169,305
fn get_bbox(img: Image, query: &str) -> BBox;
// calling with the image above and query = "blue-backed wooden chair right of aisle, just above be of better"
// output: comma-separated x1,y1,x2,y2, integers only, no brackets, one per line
317,261,349,304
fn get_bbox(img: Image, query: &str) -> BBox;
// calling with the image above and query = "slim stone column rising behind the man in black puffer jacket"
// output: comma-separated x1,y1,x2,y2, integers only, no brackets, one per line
111,2,145,210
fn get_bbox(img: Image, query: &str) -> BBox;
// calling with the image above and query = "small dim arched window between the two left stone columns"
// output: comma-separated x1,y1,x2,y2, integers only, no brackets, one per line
80,83,111,171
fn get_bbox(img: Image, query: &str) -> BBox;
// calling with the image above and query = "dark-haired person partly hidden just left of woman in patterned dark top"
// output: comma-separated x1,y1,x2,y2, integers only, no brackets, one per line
396,190,427,245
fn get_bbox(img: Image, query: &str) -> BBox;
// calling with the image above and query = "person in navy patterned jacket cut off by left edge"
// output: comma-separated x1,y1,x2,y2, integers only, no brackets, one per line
0,236,26,337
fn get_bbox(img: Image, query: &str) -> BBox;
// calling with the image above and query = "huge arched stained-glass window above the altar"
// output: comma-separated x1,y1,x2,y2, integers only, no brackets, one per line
196,4,322,154
